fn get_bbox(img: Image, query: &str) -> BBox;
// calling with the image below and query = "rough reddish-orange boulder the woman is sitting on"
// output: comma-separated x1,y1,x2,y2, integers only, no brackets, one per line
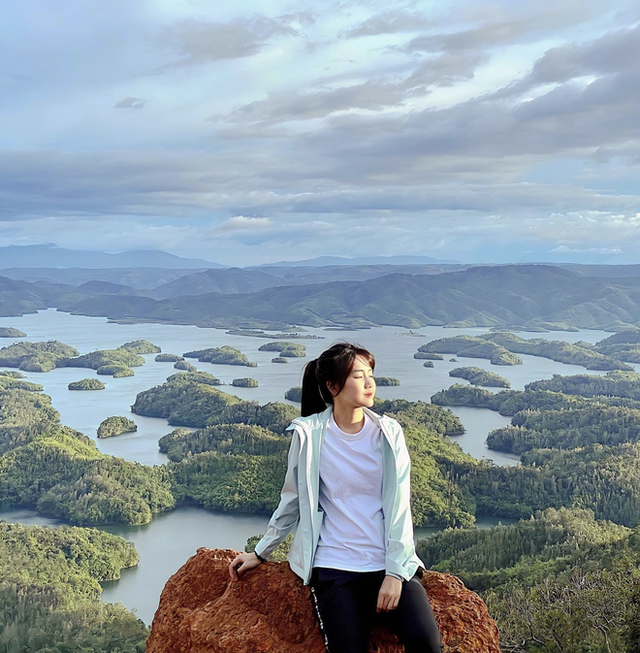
147,548,500,653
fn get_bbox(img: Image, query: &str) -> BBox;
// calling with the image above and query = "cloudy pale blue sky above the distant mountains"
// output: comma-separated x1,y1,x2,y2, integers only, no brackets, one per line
0,0,640,266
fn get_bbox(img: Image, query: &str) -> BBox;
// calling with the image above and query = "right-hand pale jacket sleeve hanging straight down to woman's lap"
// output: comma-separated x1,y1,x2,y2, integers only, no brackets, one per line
386,424,418,580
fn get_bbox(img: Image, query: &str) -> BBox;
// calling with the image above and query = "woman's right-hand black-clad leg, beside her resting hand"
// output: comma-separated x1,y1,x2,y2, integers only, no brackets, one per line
381,576,444,653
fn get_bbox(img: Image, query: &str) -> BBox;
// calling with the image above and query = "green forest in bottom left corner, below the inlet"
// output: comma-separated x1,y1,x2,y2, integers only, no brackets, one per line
0,521,148,653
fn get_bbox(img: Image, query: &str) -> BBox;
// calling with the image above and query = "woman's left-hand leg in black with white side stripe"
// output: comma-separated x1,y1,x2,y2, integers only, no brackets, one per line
311,568,384,653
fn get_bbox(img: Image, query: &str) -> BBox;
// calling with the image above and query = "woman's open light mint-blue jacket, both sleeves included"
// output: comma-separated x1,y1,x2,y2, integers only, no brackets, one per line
255,406,423,585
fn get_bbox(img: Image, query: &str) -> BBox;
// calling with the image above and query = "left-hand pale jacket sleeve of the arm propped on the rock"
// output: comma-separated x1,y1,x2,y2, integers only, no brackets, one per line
255,429,300,558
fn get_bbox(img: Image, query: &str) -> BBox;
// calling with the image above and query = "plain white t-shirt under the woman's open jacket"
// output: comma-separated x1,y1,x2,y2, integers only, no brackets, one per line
313,415,386,571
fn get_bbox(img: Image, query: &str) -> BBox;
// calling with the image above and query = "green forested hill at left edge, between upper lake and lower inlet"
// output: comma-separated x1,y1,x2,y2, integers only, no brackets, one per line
0,389,175,525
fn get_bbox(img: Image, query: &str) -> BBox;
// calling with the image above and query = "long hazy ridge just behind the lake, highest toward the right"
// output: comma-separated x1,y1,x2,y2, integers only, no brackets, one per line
45,265,640,330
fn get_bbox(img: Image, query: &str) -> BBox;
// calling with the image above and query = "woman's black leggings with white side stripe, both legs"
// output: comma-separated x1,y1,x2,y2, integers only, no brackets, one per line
311,567,444,653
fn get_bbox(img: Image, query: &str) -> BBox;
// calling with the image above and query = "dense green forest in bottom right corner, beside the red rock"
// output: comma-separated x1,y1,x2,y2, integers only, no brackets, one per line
417,509,640,653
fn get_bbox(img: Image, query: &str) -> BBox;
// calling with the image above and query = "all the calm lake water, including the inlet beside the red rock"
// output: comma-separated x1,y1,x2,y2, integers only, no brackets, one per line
0,309,610,623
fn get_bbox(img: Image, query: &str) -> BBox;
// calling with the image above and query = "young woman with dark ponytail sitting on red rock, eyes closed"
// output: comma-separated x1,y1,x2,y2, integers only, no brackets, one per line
229,343,443,653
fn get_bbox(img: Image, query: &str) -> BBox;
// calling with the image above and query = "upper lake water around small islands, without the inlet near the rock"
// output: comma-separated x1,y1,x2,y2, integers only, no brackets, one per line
0,309,609,465
